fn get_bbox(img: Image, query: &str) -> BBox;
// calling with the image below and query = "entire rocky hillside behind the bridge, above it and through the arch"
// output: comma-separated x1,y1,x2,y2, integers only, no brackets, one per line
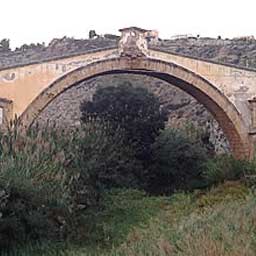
0,33,256,152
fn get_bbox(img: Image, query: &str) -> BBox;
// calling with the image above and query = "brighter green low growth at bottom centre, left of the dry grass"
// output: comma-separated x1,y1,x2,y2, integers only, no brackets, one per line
74,189,163,248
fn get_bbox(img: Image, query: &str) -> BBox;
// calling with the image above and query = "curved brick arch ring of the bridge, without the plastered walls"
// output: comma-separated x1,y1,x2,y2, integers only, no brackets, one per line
19,57,253,158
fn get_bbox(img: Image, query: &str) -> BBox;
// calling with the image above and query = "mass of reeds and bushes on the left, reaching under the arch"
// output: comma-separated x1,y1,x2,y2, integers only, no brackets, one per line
0,122,141,248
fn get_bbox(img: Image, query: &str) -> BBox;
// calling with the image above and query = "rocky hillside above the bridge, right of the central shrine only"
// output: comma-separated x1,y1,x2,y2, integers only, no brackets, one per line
156,38,256,68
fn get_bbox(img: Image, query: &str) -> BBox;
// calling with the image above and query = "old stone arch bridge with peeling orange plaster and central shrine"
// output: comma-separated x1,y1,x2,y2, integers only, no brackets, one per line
0,27,256,158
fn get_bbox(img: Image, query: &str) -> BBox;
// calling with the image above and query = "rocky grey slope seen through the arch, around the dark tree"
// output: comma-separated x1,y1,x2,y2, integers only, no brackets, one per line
36,74,229,153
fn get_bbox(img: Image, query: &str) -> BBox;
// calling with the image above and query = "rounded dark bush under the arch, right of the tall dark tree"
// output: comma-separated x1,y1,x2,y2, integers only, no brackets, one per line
149,129,207,193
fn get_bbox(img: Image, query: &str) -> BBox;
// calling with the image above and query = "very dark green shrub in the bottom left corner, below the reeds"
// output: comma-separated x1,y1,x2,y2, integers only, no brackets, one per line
0,187,58,249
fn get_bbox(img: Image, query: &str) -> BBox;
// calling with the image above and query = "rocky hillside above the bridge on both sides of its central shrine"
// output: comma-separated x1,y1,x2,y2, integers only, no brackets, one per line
0,35,256,69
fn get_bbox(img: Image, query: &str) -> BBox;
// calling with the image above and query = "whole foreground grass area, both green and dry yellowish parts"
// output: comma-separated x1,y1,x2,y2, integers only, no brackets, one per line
2,182,256,256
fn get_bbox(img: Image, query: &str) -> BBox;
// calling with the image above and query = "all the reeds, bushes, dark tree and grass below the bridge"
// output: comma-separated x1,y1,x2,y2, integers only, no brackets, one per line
0,84,256,256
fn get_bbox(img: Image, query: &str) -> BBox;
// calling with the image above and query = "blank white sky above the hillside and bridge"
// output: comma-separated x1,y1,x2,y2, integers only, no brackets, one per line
0,0,256,48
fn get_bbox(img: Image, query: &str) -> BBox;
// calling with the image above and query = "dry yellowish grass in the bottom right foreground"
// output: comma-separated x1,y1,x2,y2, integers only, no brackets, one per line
109,184,256,256
